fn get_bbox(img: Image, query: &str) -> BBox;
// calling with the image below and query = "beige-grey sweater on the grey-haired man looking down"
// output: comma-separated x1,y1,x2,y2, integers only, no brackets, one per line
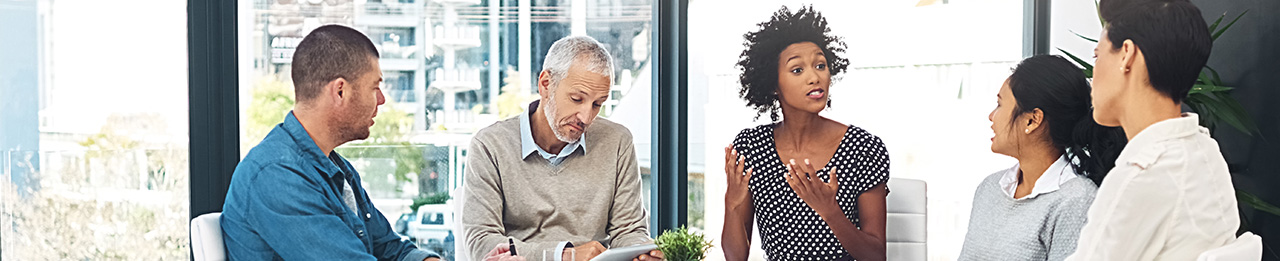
462,116,652,260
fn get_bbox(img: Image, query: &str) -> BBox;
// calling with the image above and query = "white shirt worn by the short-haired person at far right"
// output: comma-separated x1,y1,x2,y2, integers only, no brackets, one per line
1068,114,1240,261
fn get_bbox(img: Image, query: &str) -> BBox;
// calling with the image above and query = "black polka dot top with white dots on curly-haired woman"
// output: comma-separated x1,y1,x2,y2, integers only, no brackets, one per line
733,124,888,261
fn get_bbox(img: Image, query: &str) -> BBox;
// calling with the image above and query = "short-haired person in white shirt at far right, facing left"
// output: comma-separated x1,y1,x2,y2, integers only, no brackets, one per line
1070,0,1240,261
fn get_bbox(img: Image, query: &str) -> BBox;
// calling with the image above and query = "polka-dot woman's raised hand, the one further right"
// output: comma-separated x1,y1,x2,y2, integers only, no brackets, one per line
786,159,844,215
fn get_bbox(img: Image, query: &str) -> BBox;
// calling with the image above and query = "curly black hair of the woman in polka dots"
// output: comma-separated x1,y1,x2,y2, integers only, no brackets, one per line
737,5,849,122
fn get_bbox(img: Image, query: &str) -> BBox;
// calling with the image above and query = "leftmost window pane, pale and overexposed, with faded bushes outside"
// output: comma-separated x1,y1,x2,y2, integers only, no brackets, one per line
0,0,189,260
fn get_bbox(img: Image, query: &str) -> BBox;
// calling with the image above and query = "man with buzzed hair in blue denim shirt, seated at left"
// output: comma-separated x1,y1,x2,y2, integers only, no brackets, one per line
221,26,439,261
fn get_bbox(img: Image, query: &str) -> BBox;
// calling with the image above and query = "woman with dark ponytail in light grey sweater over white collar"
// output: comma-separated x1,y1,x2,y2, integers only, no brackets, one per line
960,55,1125,260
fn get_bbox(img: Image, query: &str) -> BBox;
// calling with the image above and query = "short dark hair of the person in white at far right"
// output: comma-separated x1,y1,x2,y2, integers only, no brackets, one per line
1098,0,1213,104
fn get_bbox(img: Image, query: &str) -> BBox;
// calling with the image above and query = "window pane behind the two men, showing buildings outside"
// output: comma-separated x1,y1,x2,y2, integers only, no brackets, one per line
239,0,652,258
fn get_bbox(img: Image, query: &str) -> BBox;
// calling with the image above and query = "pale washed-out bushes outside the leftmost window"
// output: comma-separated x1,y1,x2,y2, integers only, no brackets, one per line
0,114,189,260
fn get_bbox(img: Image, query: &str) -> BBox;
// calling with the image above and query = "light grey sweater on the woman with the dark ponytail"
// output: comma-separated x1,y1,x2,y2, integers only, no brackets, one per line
959,167,1097,261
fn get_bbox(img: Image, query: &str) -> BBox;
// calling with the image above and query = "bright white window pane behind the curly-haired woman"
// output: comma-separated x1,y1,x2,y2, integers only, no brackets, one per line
689,0,1023,260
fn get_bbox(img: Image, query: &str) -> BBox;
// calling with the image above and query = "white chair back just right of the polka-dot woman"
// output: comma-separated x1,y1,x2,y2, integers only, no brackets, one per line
884,178,928,261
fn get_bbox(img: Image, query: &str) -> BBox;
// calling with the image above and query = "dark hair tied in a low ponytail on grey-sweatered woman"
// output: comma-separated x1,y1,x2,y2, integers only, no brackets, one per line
1009,55,1128,184
